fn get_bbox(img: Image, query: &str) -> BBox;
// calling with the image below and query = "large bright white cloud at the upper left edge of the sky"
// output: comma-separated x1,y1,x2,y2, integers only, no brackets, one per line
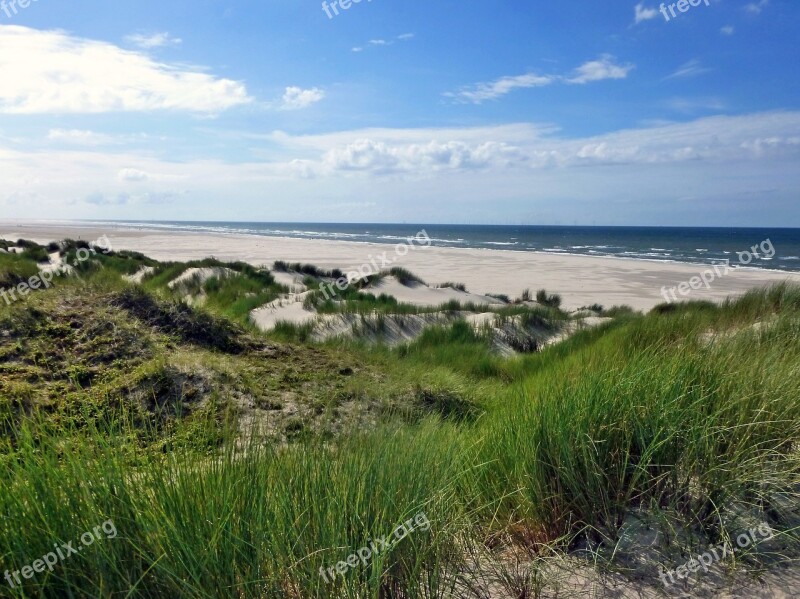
0,25,251,114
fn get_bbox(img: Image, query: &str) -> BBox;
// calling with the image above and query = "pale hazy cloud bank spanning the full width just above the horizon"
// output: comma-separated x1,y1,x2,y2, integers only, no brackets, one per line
0,111,800,224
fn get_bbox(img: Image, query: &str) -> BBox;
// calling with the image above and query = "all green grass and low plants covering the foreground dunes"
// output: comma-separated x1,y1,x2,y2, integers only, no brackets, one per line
0,241,800,599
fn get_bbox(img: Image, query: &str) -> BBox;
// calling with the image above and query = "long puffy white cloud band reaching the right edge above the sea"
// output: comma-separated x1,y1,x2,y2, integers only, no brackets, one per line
268,112,800,176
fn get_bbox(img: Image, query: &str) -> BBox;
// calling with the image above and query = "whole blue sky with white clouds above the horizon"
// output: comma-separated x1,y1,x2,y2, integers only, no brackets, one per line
0,0,800,227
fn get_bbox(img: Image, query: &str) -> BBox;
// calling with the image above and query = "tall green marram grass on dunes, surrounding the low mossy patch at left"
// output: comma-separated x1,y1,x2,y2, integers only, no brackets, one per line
0,238,800,599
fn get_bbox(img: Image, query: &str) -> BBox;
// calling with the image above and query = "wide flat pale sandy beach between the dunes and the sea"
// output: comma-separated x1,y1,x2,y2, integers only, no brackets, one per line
0,220,800,310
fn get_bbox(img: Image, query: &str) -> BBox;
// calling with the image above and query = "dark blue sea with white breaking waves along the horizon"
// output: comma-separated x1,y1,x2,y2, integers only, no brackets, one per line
84,221,800,272
